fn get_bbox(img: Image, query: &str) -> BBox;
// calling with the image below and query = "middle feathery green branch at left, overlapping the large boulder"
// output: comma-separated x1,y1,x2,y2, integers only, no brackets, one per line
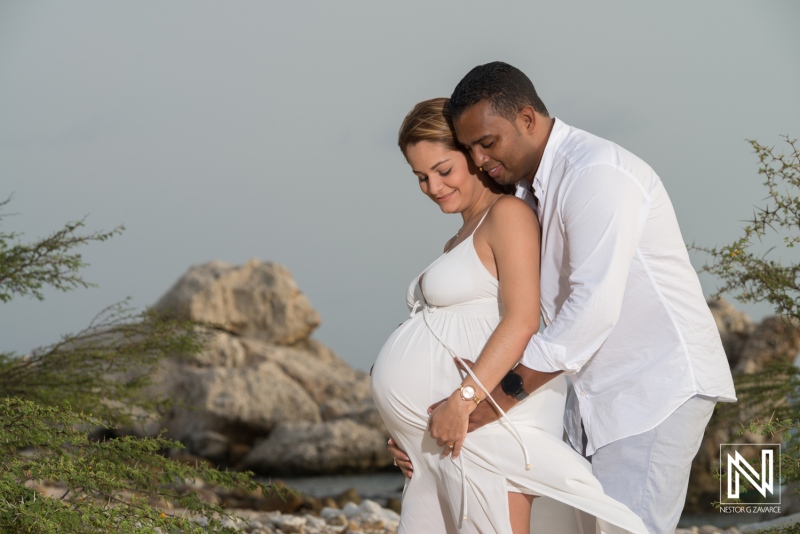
0,303,204,425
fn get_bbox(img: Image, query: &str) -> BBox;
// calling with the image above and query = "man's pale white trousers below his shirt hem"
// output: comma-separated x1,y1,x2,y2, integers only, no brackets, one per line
578,396,716,534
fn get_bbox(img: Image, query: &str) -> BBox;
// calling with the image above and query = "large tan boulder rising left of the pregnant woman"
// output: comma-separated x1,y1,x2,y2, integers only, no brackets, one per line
148,260,391,475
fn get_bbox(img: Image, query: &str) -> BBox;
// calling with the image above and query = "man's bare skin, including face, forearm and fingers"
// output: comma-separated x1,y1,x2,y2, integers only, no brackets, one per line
389,100,561,478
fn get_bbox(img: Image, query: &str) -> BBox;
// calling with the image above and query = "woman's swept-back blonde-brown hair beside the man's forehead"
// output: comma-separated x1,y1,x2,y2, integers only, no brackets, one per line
397,98,460,159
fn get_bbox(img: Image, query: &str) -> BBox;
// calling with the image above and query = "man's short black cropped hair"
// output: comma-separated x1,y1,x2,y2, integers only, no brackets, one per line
450,61,550,122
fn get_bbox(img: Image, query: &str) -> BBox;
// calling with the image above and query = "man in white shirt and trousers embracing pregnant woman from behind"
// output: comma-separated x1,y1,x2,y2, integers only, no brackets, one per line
390,62,736,534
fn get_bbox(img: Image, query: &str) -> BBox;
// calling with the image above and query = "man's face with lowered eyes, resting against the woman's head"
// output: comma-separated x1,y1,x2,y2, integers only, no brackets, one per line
453,100,538,185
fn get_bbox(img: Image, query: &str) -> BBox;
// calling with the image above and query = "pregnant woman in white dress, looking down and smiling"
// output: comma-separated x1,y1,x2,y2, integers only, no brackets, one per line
372,98,647,534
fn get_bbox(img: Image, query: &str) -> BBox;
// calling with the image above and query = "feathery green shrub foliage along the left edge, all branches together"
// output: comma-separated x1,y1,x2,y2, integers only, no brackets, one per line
0,199,283,534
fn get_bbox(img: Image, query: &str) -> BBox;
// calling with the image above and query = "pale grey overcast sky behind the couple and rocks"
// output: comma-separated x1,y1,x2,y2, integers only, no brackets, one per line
0,0,800,369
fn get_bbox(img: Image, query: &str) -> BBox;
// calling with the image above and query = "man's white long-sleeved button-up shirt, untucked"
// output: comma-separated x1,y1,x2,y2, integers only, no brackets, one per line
517,119,736,456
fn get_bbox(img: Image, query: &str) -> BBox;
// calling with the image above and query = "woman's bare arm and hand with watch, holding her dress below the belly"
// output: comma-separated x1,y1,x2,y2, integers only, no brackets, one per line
429,197,539,458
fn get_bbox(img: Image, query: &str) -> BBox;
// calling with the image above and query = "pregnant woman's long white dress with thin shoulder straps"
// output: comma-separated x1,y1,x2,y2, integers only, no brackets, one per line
372,211,647,534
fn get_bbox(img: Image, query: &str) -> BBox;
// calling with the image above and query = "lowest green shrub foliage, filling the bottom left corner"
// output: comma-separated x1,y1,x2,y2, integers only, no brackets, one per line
0,398,274,533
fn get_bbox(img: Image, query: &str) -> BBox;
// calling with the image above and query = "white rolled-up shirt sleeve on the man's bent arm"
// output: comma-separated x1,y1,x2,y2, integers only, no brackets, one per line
522,165,650,374
